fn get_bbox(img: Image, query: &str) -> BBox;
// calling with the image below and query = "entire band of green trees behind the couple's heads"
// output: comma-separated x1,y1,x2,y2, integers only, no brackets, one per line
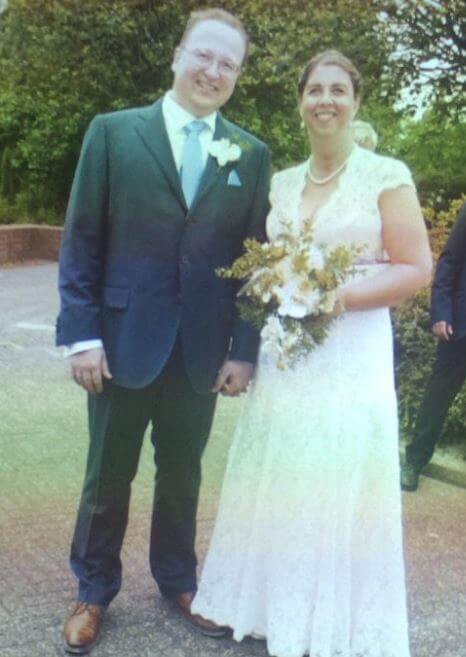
0,0,465,220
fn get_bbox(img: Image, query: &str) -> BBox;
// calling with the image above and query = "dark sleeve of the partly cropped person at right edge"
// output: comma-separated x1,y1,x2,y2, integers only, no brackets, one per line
431,204,466,324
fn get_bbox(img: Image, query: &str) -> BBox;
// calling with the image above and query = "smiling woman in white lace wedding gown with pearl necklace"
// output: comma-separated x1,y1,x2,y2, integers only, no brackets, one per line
192,51,431,657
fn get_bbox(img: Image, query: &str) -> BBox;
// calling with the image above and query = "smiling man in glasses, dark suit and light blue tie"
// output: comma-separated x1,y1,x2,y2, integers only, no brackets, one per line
57,9,270,654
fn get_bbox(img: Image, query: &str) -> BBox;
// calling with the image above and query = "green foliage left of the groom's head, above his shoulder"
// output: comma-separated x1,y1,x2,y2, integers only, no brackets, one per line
0,0,184,216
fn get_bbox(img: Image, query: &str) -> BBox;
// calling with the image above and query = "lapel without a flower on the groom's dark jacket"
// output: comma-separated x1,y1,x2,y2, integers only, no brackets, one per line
136,100,187,210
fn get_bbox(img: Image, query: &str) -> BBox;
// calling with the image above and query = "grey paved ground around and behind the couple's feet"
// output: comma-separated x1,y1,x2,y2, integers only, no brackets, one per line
0,263,466,657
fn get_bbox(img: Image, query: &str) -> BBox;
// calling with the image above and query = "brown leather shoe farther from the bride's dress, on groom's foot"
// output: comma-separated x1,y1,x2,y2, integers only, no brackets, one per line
65,602,104,655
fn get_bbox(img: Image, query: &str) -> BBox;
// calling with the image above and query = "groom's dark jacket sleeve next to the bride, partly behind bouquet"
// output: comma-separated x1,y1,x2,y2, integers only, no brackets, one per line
229,146,272,363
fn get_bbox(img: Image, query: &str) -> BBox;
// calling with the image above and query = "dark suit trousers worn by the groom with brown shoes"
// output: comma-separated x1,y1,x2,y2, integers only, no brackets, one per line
70,340,216,607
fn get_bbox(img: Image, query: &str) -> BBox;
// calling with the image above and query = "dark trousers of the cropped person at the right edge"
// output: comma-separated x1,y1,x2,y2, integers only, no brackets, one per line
406,336,466,470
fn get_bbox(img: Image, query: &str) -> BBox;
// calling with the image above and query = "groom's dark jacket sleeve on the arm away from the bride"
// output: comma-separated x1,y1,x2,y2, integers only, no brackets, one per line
56,116,108,345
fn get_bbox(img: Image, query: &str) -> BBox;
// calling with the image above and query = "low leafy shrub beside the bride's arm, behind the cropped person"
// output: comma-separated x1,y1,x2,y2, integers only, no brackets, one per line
395,197,466,442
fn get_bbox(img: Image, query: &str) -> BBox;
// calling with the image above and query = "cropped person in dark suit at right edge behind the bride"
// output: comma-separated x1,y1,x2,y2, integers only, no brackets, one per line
401,204,466,491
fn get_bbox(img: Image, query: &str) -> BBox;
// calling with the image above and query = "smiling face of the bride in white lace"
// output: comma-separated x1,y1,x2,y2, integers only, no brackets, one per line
299,64,359,136
